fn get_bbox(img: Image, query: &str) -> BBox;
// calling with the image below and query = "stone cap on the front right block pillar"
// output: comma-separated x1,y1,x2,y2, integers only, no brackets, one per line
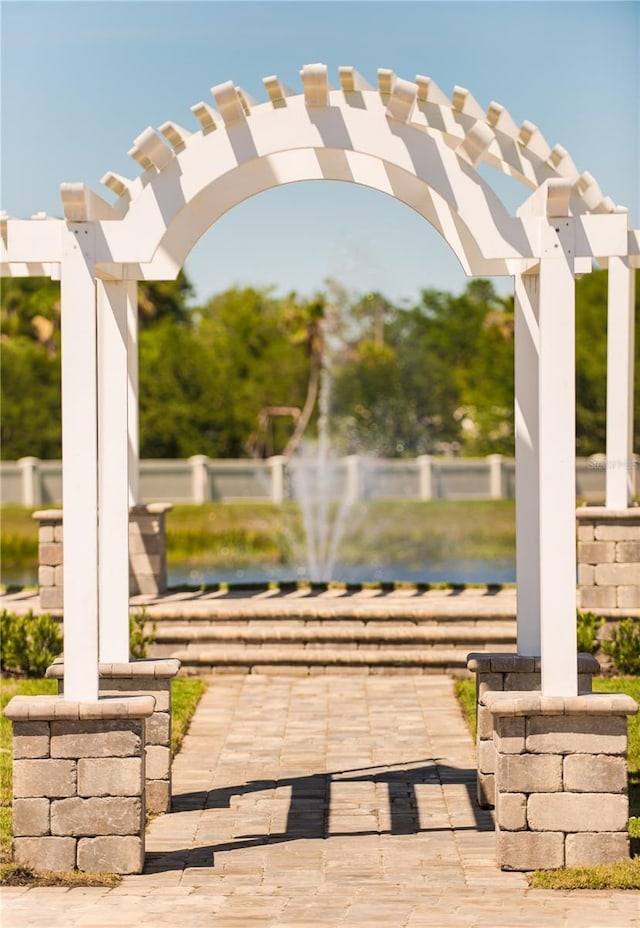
480,690,638,716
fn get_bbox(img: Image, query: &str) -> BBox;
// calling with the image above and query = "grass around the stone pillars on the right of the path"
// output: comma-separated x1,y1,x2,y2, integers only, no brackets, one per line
454,677,640,889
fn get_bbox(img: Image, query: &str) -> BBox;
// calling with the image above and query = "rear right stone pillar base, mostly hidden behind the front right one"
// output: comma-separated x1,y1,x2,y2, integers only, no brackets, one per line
467,651,600,809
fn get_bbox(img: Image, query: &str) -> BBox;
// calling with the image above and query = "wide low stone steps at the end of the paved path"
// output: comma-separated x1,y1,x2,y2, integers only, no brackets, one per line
148,596,516,673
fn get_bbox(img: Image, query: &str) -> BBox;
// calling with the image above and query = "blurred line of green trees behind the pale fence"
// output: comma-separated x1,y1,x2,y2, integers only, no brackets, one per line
1,271,640,460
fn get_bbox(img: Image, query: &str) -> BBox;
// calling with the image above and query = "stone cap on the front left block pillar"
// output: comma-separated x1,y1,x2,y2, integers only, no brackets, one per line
4,696,156,722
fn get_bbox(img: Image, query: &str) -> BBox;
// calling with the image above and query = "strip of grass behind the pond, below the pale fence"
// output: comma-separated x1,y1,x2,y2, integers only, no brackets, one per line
0,500,515,577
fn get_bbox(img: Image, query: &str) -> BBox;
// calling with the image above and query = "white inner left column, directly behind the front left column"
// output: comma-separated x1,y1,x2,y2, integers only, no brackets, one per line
97,280,130,663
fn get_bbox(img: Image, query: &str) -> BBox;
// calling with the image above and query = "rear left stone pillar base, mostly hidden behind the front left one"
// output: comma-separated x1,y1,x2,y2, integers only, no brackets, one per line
46,658,180,813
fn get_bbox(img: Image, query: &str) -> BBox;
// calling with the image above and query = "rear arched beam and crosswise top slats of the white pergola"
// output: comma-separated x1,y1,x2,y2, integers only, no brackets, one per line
84,64,614,252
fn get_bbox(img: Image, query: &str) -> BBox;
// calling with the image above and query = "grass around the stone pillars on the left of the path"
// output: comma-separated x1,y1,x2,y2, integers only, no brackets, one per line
0,677,206,886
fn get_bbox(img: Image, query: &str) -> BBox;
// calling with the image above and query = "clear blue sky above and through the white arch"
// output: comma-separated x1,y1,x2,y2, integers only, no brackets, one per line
0,0,640,301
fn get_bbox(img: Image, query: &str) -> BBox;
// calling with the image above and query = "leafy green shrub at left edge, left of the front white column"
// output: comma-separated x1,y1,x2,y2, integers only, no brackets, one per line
0,609,62,677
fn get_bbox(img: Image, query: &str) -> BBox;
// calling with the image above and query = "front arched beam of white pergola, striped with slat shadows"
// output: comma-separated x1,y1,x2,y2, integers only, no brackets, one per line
77,89,533,273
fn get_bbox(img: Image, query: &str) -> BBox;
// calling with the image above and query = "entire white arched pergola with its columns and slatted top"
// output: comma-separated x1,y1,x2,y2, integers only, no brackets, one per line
0,64,640,700
